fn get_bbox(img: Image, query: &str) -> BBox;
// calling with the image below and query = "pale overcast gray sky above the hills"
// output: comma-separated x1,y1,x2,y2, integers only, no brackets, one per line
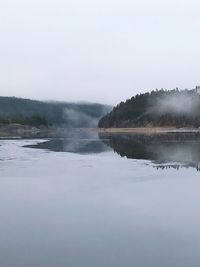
0,0,200,104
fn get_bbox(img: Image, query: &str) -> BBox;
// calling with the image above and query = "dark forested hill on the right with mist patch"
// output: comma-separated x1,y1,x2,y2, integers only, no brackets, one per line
99,88,200,128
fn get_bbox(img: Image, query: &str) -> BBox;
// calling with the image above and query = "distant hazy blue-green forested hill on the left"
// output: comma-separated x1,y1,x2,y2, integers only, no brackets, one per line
0,97,111,128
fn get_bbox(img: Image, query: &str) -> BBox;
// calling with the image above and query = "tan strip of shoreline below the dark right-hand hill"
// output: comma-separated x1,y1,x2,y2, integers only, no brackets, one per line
98,127,200,134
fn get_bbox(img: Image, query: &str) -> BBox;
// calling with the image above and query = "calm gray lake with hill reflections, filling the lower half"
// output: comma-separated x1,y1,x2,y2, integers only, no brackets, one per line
0,131,200,267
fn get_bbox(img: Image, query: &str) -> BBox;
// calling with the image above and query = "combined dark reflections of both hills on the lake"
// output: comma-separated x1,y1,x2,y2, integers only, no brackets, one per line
28,132,200,171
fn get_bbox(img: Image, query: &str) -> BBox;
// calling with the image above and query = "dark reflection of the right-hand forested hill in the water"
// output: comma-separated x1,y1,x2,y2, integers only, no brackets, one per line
100,133,200,169
